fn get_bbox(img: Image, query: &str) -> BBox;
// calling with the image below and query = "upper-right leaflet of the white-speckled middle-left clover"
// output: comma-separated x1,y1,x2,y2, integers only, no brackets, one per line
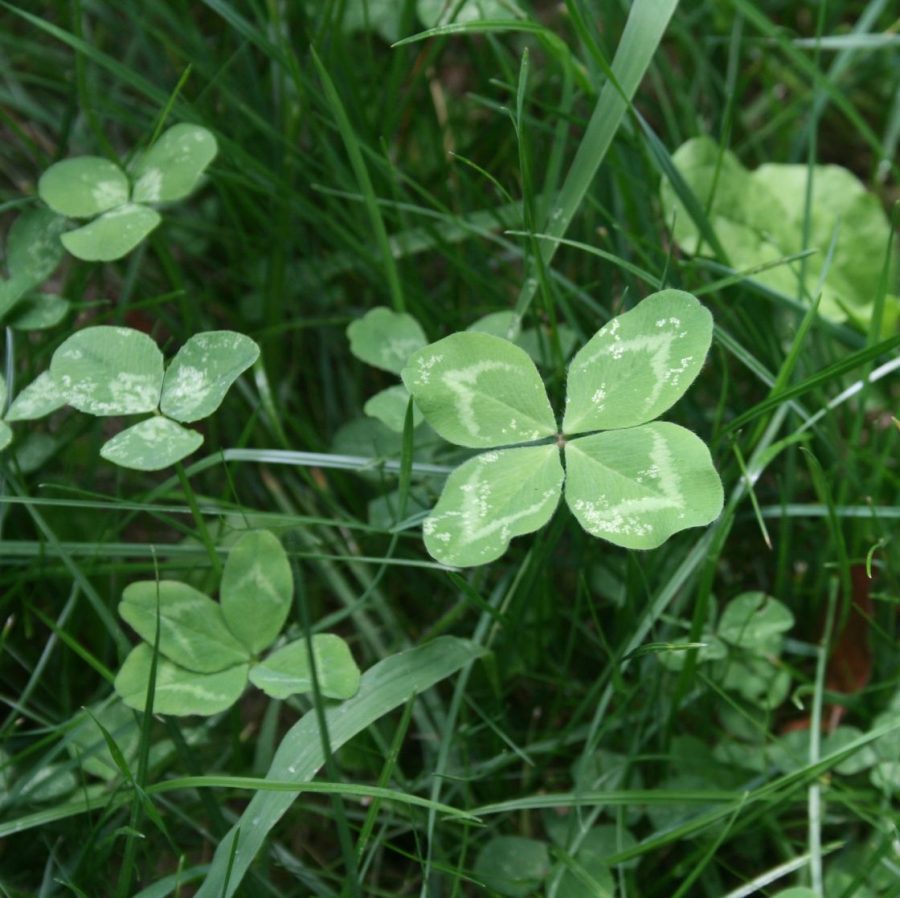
160,331,259,423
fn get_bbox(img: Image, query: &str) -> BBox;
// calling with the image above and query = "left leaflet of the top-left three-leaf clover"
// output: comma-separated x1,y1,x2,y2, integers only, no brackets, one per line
38,156,129,218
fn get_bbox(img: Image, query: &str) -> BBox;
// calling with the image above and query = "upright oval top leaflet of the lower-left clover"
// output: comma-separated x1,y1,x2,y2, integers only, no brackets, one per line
220,530,294,654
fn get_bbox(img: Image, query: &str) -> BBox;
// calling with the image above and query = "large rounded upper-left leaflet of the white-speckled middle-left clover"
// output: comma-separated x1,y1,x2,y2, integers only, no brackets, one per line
50,325,163,416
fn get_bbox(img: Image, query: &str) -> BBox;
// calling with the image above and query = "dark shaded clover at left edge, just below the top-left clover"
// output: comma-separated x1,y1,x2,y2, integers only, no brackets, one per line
0,209,69,330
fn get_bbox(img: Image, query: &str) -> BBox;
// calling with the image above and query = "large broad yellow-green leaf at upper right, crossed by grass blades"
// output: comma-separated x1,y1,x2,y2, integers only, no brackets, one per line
660,137,900,334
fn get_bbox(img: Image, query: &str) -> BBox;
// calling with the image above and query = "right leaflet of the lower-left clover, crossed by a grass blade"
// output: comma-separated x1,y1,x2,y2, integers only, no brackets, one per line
250,633,360,699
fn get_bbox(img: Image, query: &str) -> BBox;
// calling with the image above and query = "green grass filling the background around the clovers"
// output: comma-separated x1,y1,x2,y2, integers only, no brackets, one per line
0,0,900,898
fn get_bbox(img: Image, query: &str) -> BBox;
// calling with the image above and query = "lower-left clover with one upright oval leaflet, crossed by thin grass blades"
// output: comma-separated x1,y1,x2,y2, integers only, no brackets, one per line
115,530,360,715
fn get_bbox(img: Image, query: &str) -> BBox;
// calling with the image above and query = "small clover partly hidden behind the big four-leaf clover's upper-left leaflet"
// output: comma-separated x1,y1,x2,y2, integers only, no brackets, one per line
347,307,575,433
